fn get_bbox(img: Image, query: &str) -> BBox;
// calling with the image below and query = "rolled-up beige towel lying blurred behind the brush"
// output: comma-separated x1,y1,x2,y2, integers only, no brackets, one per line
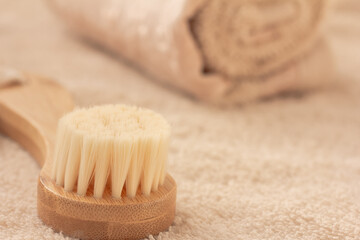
49,0,330,103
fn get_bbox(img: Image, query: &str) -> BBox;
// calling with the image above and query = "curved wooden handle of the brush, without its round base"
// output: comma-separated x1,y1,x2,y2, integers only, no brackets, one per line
0,75,74,166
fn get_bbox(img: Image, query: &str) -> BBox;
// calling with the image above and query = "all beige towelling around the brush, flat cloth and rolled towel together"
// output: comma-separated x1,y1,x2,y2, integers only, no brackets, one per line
0,0,360,239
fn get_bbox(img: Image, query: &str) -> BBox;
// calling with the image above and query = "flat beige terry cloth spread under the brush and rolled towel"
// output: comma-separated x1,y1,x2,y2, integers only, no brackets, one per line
0,0,360,240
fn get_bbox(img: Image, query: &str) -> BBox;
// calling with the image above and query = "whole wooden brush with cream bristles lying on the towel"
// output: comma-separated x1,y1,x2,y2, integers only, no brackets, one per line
0,75,176,239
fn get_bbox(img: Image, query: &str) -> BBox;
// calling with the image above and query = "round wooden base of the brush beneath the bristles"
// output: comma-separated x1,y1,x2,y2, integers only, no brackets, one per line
38,175,176,239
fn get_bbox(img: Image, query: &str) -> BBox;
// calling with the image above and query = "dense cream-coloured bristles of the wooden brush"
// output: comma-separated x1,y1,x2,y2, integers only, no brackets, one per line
51,105,170,198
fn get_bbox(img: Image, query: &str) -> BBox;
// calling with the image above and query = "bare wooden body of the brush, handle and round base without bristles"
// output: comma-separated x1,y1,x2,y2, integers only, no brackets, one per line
0,75,176,239
